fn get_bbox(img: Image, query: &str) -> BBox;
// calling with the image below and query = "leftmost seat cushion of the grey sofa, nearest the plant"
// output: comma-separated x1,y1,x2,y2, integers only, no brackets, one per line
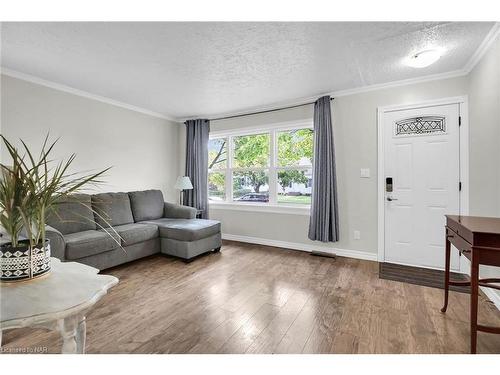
64,230,120,259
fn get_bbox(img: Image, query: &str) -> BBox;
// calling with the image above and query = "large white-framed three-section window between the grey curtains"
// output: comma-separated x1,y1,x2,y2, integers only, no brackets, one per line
208,127,313,206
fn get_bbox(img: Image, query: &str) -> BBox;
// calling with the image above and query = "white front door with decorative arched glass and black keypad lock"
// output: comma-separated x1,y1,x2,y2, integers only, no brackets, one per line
383,104,460,270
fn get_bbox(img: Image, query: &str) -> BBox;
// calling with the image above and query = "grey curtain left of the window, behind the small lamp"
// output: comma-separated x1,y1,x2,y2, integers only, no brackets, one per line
183,120,210,219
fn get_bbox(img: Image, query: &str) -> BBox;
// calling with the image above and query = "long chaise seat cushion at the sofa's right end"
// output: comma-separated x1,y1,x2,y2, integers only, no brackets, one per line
140,218,220,241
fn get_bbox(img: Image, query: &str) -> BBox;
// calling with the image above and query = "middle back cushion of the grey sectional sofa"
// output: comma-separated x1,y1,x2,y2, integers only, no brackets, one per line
92,193,134,228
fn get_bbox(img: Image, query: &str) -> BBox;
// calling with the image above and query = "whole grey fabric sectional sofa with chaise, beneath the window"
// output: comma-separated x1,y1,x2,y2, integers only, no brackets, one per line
47,190,221,270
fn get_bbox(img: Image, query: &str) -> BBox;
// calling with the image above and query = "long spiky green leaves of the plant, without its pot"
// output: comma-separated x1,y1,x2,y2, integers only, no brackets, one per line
0,135,116,248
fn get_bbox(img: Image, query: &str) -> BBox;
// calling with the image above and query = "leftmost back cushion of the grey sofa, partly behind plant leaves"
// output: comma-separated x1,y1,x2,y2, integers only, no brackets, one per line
46,194,97,234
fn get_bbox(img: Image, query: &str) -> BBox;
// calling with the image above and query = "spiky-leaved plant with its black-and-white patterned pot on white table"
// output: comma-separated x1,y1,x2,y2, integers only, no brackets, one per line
0,135,113,281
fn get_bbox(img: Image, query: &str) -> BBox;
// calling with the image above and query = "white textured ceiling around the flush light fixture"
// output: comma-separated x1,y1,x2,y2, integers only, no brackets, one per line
1,22,493,118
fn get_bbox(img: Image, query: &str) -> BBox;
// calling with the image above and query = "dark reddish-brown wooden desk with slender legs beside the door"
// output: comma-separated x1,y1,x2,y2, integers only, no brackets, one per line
441,215,500,353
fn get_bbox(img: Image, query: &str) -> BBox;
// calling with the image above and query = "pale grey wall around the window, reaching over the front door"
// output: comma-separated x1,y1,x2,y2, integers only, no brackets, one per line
206,77,468,256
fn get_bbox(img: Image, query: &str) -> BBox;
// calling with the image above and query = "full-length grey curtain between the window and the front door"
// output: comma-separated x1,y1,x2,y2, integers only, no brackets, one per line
309,96,339,242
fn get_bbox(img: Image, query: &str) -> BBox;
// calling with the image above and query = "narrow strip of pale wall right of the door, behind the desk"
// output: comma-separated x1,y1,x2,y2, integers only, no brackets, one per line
468,35,500,308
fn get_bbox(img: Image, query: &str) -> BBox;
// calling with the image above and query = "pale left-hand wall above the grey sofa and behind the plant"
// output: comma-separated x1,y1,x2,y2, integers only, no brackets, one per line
1,75,180,201
